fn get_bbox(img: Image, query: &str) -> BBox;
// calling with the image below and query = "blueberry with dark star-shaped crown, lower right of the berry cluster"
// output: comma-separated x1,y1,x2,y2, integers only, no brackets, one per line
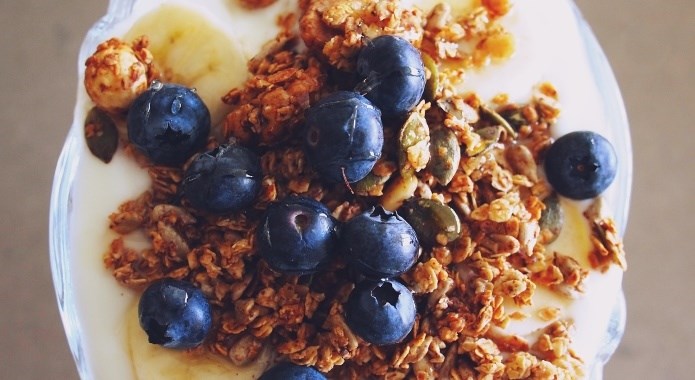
345,280,415,346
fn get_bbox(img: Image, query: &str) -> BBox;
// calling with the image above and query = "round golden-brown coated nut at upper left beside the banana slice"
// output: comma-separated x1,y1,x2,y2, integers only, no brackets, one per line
84,38,157,114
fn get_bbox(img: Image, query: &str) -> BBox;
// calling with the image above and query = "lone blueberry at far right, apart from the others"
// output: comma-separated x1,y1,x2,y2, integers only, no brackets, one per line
545,131,617,199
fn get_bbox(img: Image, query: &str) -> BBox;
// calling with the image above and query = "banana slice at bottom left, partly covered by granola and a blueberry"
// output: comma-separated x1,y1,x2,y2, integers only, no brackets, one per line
126,304,269,380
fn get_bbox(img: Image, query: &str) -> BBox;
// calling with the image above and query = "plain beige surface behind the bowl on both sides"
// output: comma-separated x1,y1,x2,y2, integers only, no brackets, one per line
0,0,695,379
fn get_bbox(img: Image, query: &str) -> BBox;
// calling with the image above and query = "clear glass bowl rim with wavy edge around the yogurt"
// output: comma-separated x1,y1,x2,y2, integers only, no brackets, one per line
49,0,632,380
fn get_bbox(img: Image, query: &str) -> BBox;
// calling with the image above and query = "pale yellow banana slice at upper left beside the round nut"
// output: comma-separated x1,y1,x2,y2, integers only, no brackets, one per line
124,5,247,125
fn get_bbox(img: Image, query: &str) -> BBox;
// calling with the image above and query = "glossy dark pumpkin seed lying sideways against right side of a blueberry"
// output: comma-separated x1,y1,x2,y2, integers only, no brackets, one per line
398,198,461,246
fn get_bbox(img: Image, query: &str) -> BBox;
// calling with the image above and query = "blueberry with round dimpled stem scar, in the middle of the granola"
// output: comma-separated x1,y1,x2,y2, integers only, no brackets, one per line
258,196,338,274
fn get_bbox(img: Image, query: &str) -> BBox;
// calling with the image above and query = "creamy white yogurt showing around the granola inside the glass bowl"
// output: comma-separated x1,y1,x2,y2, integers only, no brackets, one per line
69,0,622,380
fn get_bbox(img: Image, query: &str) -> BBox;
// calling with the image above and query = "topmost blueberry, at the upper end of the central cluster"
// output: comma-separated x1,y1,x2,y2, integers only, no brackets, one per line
356,35,426,117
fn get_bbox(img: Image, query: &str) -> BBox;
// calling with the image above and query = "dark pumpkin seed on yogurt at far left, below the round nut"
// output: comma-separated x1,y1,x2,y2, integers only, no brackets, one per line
84,107,118,164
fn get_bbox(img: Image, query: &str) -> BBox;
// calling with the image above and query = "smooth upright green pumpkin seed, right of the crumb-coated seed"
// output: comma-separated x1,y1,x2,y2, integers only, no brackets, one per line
428,128,461,186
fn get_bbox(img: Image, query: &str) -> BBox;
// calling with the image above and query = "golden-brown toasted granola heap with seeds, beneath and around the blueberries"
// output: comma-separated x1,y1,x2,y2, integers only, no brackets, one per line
100,0,625,379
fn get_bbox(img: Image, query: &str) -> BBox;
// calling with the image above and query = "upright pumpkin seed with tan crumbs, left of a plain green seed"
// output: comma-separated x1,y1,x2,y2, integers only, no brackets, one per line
398,112,430,177
